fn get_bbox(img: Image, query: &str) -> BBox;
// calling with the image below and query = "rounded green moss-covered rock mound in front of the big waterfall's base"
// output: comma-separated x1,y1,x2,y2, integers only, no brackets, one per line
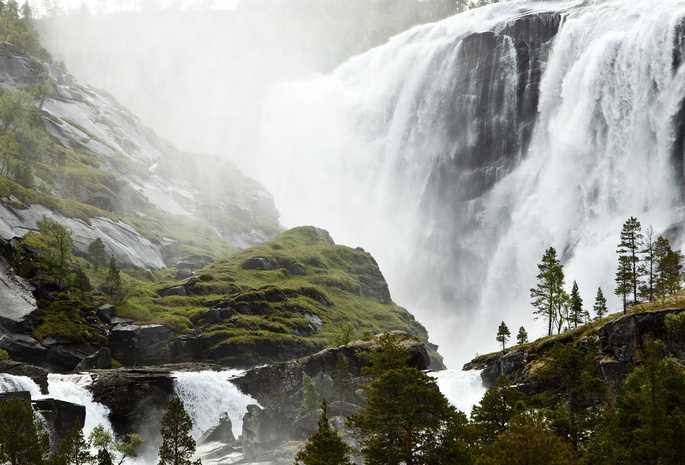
110,227,440,365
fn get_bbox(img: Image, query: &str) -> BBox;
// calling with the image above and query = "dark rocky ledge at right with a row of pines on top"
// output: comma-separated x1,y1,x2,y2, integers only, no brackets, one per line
464,308,685,394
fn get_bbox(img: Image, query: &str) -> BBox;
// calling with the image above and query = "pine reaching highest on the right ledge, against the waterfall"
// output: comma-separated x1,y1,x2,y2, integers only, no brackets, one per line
616,216,643,313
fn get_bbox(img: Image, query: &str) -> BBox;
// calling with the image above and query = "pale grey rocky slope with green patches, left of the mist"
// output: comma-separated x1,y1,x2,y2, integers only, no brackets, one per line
0,43,280,269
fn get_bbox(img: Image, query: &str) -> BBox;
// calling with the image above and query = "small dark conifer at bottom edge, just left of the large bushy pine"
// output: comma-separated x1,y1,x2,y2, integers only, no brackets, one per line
295,399,351,465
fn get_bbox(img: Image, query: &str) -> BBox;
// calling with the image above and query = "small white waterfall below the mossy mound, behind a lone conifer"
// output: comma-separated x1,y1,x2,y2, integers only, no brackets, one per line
173,370,257,439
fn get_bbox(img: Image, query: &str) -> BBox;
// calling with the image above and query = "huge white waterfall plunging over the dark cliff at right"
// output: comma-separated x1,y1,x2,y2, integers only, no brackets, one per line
251,0,685,366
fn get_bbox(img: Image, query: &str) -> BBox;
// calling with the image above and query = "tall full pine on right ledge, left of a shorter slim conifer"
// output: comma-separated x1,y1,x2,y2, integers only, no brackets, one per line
530,247,566,336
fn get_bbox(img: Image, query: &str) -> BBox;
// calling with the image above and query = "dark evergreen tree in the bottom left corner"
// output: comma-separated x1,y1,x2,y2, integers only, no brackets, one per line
0,397,50,465
